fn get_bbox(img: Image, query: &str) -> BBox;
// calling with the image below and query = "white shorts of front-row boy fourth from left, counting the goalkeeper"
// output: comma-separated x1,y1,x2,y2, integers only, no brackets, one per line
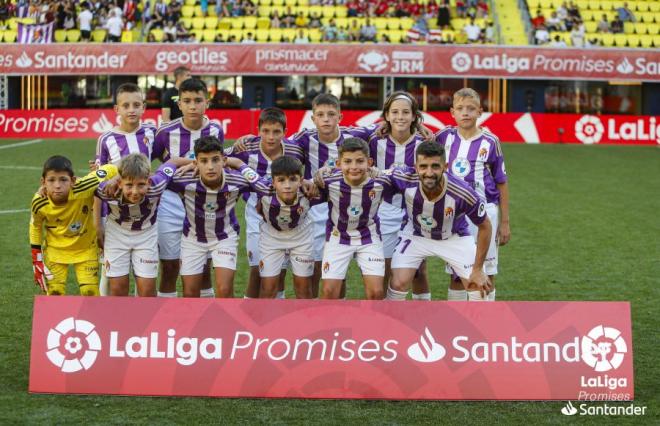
259,223,314,277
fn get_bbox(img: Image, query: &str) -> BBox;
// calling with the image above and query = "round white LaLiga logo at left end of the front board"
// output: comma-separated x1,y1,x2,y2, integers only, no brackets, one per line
46,317,101,373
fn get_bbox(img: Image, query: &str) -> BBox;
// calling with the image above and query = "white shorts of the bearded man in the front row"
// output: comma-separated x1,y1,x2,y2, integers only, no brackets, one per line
392,233,477,278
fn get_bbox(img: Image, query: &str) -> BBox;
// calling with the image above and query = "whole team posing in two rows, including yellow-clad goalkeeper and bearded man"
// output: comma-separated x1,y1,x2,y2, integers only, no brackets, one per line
30,78,510,300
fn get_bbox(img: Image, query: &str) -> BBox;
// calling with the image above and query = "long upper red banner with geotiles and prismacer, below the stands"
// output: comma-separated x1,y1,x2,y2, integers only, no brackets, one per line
0,43,660,81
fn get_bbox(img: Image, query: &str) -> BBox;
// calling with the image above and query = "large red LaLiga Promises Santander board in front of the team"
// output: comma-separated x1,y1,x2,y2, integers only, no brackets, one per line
29,296,634,400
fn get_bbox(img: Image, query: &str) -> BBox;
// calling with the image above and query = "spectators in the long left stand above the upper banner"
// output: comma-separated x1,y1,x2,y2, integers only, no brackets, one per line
0,0,495,43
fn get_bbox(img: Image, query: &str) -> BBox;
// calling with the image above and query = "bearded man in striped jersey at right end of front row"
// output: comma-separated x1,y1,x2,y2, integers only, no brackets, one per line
387,142,492,300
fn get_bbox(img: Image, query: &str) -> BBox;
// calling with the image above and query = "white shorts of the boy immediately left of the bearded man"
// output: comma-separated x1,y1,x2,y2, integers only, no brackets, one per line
321,236,385,280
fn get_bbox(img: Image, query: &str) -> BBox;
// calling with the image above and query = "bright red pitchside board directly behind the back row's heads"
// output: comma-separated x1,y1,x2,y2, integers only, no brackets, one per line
0,109,660,145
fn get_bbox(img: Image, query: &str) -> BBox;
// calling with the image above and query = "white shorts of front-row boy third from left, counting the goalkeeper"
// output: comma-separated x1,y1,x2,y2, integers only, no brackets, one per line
181,236,238,275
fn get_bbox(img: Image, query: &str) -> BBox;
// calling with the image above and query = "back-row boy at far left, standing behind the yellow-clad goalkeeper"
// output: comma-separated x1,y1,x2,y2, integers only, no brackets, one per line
90,83,156,296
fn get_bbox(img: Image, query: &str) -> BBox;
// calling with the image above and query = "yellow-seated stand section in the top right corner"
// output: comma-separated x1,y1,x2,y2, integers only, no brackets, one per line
526,0,660,48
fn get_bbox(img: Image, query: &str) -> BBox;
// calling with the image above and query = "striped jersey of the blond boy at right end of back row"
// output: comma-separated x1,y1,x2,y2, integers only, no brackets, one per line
436,126,507,204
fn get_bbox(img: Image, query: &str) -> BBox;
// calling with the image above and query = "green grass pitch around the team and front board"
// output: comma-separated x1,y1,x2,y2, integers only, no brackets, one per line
0,139,660,424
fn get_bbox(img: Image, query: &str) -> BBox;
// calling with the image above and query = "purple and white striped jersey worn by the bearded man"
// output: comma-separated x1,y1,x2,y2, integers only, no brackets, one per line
385,168,486,240
